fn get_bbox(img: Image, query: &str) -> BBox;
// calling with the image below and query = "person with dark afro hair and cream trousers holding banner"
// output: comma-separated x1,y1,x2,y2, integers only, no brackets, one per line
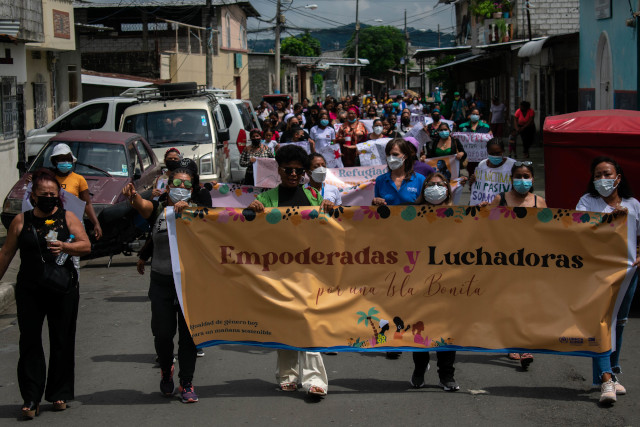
248,145,333,396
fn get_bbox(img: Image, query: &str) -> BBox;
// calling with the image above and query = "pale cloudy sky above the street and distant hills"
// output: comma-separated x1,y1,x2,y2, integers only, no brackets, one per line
248,0,455,37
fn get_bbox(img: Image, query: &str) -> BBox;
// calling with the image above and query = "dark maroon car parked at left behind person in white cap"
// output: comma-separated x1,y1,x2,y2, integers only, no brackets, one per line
0,130,161,258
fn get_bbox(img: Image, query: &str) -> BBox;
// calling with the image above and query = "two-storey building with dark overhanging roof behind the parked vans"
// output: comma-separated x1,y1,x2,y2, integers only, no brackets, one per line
75,0,260,98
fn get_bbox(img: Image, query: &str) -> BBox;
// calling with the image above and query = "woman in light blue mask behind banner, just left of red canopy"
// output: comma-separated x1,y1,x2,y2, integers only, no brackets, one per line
488,161,547,370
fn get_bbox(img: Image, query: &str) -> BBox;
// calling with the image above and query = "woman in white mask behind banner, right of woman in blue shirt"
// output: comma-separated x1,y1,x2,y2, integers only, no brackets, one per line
409,172,460,391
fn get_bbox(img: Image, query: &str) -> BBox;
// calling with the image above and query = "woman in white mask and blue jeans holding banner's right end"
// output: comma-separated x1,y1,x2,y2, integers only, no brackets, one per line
576,157,640,404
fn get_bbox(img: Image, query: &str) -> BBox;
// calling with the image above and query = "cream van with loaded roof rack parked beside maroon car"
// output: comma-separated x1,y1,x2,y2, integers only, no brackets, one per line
120,83,230,182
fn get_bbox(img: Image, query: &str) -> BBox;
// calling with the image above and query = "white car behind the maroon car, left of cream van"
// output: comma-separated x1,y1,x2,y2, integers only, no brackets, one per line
26,96,137,160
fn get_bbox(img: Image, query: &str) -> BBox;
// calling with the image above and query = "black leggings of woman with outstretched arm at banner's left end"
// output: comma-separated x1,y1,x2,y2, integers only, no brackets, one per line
149,271,197,383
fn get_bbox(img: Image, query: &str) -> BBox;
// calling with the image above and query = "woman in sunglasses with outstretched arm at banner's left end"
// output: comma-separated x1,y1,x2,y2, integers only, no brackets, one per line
122,167,198,403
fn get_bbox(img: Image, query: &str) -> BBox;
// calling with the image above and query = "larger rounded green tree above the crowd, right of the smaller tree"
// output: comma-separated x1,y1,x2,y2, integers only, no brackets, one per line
344,26,405,76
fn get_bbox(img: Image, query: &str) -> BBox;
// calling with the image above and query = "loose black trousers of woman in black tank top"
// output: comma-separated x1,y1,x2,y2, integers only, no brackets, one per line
16,280,79,403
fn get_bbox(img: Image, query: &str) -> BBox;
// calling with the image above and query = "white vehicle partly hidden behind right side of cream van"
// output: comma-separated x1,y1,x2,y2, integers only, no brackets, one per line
218,99,262,182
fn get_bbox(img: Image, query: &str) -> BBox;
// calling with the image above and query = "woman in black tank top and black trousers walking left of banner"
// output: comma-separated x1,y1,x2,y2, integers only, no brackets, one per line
0,169,91,418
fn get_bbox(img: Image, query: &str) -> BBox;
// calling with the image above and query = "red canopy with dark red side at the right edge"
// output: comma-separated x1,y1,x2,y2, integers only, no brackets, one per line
543,110,640,209
